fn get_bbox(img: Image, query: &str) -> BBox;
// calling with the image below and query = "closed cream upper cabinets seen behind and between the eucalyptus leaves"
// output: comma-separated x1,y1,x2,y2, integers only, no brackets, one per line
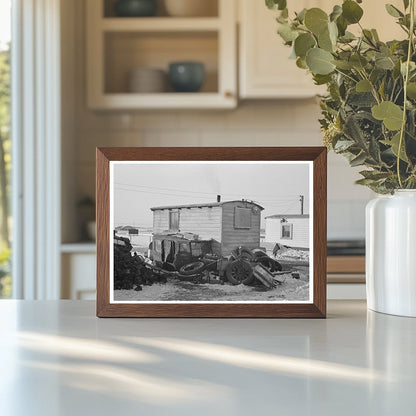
238,0,404,99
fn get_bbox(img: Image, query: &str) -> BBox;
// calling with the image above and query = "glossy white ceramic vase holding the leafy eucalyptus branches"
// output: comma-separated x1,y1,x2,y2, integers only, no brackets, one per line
366,190,416,317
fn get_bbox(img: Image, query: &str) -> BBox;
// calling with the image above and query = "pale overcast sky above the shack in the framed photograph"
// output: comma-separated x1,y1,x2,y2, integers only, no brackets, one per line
113,162,309,227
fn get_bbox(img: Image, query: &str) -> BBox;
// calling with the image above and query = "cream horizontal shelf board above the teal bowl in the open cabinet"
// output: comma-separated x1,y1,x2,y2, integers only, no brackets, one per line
101,17,221,32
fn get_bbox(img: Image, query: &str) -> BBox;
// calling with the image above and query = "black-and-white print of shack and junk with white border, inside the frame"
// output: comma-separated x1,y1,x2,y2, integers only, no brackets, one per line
110,161,313,303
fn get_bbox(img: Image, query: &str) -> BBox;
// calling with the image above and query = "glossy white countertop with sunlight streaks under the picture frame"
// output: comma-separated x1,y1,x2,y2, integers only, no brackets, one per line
0,301,416,416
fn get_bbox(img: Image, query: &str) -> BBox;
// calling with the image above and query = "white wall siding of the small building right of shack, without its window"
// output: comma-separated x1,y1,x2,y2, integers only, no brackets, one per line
265,218,309,248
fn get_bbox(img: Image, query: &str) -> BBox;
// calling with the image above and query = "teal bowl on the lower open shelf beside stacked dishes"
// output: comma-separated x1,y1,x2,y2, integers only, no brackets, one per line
169,62,205,92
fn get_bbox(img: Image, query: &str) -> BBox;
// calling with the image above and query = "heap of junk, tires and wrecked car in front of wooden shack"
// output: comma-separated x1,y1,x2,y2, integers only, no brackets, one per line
114,229,300,291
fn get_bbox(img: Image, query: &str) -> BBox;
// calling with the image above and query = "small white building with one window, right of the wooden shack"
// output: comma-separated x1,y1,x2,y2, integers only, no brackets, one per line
265,214,309,249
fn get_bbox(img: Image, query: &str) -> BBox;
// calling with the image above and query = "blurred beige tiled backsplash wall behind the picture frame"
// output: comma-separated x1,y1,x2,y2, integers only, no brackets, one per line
71,100,372,239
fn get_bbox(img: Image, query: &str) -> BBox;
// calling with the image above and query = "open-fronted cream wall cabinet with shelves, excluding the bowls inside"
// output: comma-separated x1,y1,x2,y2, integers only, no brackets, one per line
86,0,237,110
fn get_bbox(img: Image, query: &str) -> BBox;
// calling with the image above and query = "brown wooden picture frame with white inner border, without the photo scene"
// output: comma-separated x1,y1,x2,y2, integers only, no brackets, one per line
96,147,327,318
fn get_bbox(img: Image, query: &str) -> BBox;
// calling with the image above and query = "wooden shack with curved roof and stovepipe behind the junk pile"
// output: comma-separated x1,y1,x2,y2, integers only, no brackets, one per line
151,200,263,256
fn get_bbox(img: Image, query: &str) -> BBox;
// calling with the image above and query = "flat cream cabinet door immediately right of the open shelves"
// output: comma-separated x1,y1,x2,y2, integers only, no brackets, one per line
239,0,324,98
